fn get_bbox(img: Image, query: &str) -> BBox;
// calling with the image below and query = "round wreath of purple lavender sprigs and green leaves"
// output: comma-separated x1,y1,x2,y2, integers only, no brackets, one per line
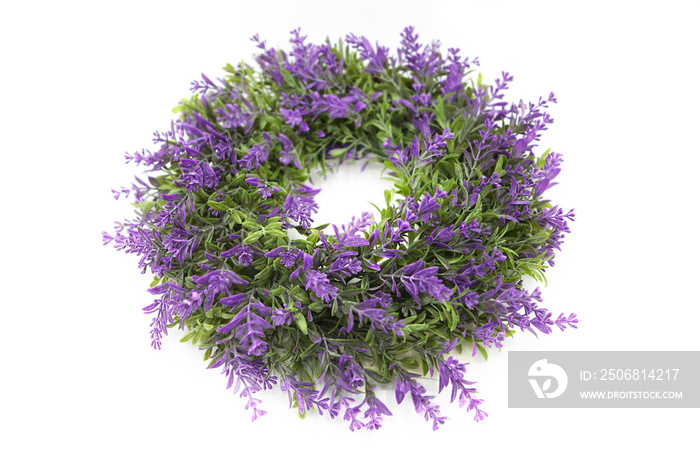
103,27,577,430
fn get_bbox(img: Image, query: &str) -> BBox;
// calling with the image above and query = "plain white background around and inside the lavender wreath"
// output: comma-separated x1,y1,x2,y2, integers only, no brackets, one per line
0,0,700,465
